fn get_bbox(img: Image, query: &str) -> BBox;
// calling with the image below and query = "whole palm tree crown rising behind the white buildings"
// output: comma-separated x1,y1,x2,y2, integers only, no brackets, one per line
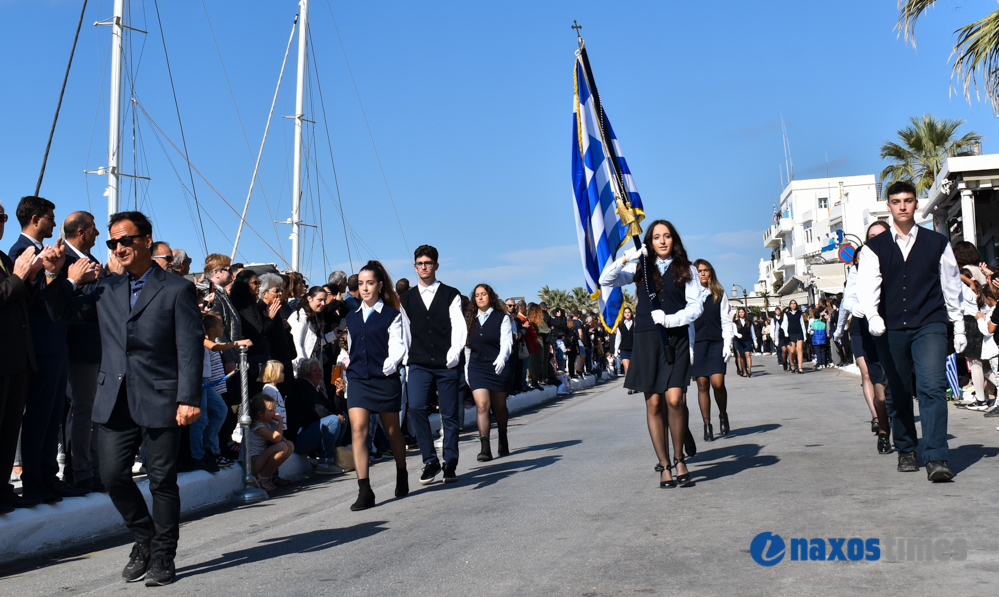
881,114,982,195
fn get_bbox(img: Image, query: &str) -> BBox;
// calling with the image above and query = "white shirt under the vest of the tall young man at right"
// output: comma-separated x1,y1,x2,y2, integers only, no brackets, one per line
857,222,964,334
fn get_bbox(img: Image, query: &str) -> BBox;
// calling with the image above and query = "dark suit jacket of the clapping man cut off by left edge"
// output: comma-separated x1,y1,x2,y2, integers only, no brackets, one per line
0,251,41,375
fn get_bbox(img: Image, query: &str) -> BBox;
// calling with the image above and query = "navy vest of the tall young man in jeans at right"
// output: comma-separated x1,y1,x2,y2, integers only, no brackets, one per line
867,228,947,330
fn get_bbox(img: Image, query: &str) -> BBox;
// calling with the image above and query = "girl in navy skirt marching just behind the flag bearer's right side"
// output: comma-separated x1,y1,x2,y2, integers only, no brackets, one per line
690,259,735,442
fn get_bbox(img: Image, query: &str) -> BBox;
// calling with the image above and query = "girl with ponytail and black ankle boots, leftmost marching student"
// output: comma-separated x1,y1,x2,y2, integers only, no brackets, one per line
341,261,409,511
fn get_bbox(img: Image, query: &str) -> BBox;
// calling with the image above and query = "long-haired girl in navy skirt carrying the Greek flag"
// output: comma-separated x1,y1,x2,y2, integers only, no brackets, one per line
600,220,703,488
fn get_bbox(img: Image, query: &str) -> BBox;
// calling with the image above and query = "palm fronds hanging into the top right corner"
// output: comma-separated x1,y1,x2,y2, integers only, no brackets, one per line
895,0,999,115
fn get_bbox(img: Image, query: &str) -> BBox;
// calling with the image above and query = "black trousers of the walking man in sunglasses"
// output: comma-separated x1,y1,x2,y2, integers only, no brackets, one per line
99,384,181,559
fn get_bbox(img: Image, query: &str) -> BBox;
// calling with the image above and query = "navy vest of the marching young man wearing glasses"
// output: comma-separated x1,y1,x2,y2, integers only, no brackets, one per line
399,283,460,369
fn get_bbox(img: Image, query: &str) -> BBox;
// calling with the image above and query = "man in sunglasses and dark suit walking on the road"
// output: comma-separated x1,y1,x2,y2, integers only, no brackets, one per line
54,211,204,586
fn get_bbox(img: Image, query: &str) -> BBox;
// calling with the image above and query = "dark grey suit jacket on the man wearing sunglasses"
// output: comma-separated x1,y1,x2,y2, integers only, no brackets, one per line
71,263,205,427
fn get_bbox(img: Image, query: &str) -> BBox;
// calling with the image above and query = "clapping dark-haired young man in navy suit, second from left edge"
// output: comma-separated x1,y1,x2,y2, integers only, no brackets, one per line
10,196,87,503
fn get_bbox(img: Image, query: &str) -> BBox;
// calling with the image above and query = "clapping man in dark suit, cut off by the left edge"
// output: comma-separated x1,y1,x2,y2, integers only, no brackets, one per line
0,205,51,514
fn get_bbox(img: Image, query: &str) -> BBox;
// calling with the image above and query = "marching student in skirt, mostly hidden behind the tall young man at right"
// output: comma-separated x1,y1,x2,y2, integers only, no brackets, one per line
834,221,891,454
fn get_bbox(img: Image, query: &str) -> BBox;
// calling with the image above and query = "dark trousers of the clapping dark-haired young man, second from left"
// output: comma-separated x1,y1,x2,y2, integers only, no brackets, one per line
21,354,69,493
